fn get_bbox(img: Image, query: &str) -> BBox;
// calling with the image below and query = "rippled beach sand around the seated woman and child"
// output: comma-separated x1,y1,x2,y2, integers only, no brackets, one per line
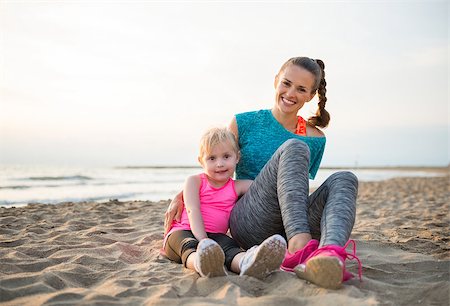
0,176,450,306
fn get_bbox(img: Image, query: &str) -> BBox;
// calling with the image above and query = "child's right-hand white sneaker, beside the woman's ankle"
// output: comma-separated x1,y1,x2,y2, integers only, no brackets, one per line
239,235,287,279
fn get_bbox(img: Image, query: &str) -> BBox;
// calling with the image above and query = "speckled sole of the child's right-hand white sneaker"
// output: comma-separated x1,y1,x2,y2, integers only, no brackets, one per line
240,236,286,279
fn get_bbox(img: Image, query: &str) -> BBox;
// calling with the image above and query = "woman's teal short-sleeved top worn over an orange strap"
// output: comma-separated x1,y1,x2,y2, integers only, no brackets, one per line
236,109,326,180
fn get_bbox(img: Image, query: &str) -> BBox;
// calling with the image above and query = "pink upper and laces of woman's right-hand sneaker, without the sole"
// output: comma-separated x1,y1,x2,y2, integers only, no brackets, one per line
305,240,362,282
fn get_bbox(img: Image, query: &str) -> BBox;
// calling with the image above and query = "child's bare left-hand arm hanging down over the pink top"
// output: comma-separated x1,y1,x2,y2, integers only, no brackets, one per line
183,175,208,241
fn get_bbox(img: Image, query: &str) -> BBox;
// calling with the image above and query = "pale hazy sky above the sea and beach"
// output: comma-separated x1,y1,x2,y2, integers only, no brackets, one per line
0,0,449,166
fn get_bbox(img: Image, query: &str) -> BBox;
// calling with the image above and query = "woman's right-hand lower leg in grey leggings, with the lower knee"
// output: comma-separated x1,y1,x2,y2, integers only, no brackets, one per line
308,171,358,248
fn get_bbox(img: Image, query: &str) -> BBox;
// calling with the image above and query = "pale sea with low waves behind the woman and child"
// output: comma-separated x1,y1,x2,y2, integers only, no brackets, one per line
0,166,450,207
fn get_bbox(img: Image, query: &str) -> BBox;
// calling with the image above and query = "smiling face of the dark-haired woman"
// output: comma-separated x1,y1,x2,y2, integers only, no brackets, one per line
274,65,315,115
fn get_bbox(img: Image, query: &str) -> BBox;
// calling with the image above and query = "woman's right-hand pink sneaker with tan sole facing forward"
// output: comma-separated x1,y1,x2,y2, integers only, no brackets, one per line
294,240,362,289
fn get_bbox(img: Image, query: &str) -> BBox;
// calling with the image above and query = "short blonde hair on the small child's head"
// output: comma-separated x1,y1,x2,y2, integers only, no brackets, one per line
199,127,239,157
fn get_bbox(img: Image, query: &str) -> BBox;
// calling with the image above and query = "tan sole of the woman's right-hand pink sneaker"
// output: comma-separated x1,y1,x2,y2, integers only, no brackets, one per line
294,256,343,289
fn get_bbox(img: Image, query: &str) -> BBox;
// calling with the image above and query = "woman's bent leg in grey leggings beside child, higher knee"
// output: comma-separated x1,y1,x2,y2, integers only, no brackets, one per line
230,139,310,249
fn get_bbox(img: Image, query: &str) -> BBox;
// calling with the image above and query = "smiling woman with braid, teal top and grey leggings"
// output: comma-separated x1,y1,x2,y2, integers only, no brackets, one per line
166,57,359,288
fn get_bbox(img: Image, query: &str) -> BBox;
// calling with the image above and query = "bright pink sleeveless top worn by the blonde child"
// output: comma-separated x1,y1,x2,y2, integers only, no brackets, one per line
164,173,238,241
